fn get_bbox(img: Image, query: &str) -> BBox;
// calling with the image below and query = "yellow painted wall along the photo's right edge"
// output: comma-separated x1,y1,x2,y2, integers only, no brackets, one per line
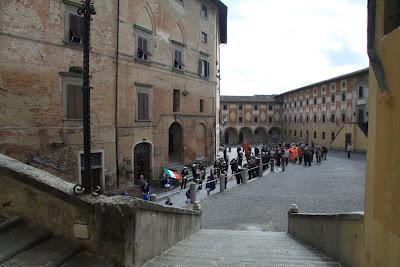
365,0,400,267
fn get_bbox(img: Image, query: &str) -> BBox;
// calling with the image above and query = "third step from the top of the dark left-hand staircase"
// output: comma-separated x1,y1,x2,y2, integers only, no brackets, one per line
1,237,83,267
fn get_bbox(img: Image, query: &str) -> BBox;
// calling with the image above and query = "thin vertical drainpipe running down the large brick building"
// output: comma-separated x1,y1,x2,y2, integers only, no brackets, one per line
114,0,120,189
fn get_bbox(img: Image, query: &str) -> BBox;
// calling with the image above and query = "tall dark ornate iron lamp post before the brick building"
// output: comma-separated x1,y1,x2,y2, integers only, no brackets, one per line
78,0,96,193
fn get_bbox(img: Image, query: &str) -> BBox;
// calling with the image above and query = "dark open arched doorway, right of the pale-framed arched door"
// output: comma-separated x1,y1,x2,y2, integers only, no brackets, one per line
168,122,183,163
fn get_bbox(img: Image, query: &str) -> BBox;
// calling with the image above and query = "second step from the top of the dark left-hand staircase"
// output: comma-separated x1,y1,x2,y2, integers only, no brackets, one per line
0,223,51,263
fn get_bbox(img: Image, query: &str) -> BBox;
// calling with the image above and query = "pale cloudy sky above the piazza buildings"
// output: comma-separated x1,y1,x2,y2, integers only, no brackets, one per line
220,0,368,95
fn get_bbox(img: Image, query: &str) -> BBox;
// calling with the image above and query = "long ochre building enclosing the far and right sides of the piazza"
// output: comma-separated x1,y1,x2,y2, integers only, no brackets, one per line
220,69,368,151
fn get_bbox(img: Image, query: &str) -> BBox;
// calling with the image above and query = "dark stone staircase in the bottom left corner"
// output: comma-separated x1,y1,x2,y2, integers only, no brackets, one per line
0,216,114,267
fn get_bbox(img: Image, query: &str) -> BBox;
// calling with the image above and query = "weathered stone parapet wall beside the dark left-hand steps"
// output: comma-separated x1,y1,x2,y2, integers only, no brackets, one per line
0,154,200,266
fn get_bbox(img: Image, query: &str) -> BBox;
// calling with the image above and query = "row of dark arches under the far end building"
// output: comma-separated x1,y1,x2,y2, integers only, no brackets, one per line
220,127,281,145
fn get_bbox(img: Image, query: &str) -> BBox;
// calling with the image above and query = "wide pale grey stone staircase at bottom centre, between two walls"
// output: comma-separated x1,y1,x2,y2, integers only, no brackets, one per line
143,229,341,267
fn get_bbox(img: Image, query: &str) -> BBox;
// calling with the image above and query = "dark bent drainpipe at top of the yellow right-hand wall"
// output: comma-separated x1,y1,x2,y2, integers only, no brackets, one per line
367,0,389,93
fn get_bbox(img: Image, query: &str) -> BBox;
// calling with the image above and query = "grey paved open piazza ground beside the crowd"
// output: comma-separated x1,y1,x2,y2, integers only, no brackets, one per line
201,151,366,231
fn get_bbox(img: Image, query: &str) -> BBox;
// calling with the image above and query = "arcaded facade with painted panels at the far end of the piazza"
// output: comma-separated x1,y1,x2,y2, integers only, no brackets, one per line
219,95,281,145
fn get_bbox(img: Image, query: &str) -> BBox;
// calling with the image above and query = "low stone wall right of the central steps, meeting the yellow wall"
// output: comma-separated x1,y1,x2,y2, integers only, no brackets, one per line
288,213,366,267
